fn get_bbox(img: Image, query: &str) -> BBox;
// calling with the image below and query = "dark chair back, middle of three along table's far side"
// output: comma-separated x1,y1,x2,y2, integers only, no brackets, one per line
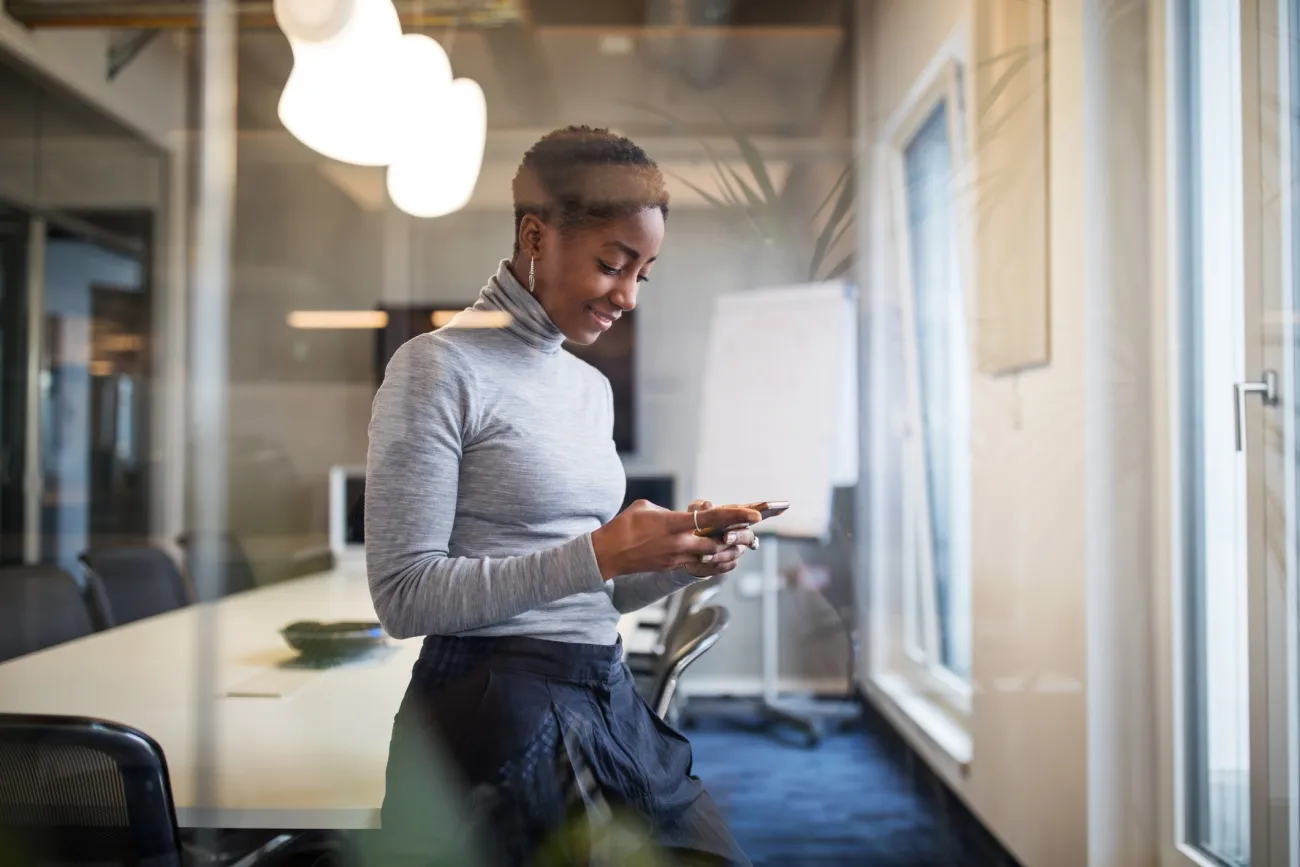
81,545,194,628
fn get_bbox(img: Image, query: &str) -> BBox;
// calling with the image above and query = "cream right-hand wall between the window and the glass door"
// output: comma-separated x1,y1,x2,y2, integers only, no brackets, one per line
858,0,1154,867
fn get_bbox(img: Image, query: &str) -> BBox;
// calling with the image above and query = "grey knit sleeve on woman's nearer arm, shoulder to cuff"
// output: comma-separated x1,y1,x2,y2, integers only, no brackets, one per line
365,337,605,638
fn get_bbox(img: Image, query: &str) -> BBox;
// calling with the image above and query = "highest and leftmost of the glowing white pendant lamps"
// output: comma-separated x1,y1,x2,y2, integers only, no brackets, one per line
276,0,402,165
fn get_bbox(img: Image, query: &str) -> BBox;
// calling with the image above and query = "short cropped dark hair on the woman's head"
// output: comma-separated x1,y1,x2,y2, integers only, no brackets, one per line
511,126,668,253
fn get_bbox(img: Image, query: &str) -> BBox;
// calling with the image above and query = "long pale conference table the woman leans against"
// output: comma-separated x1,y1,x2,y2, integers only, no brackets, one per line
0,563,653,829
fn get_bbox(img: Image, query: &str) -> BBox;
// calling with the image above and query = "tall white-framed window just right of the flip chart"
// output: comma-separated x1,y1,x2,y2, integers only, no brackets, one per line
874,44,971,715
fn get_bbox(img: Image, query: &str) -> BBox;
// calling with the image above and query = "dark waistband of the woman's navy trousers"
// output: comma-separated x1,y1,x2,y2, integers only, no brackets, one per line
420,636,624,684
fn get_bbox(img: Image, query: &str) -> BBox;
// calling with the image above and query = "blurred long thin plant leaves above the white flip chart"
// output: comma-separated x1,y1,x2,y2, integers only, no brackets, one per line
637,103,857,281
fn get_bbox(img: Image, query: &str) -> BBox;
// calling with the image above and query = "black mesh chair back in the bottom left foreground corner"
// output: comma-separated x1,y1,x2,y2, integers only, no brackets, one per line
0,714,181,867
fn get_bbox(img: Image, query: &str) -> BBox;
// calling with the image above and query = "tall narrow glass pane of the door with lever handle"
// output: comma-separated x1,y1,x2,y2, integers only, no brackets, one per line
1166,0,1253,867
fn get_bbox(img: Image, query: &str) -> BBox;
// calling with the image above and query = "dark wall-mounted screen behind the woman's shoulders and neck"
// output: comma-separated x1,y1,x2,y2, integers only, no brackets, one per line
374,302,637,454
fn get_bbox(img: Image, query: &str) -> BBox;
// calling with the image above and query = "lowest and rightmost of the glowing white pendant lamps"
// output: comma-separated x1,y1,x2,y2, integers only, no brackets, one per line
387,78,488,217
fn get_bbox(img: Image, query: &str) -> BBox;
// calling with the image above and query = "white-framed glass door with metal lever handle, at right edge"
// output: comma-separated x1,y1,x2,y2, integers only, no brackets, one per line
1164,0,1300,867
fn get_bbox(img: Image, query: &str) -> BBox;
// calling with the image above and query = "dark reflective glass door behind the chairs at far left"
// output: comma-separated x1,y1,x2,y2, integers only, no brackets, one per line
40,214,152,569
